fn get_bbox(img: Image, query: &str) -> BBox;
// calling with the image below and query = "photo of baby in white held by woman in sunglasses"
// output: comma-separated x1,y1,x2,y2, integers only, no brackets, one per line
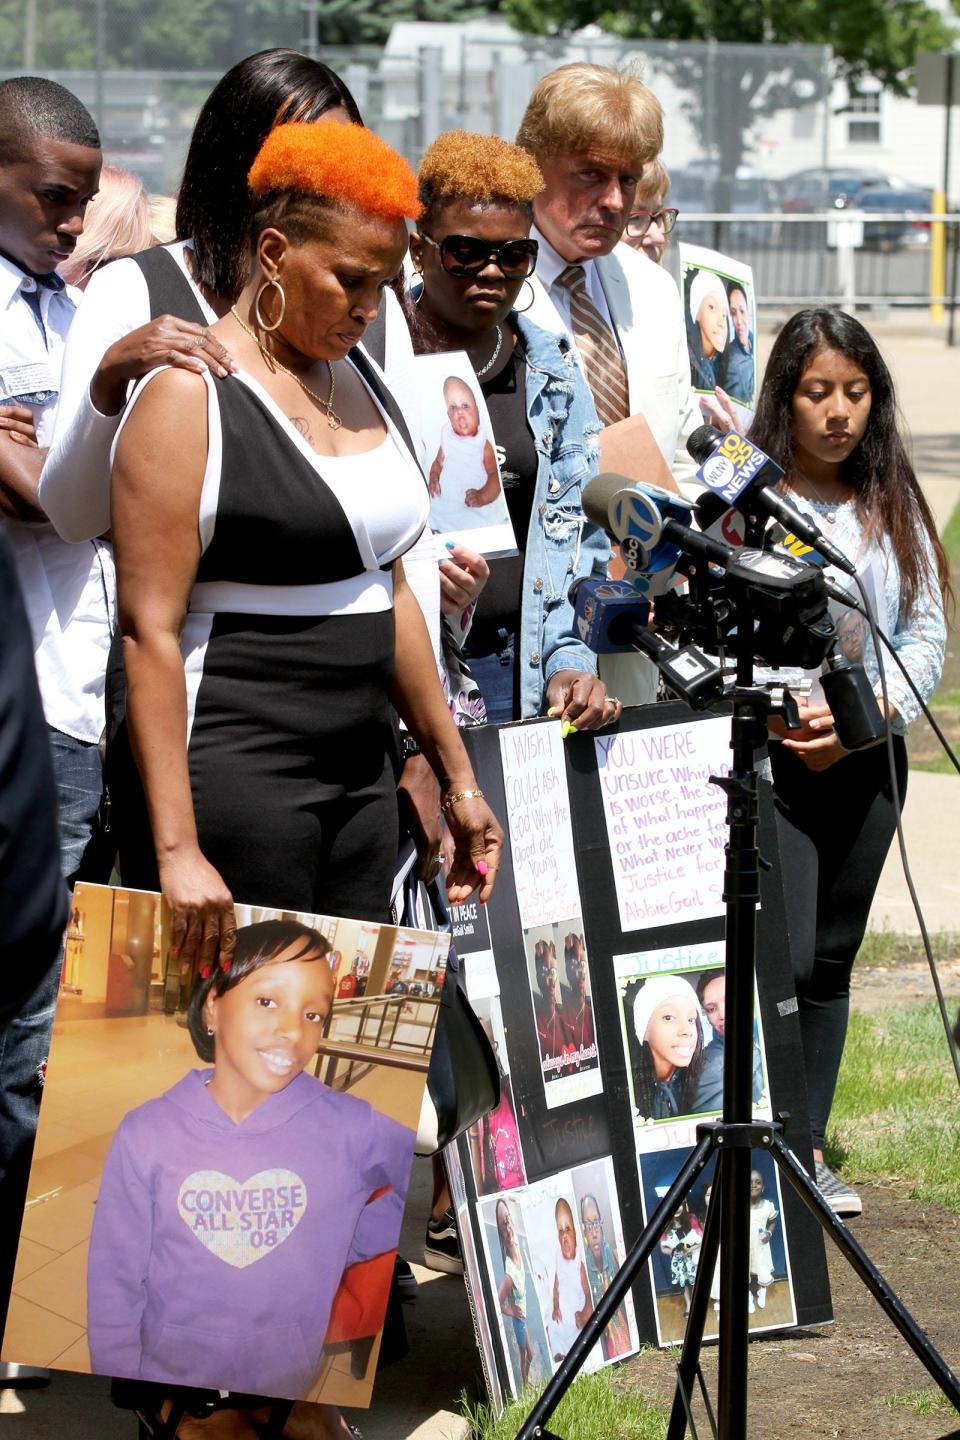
415,351,517,556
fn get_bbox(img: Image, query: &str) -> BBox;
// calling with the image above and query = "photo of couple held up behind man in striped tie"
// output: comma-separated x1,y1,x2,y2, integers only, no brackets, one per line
679,240,760,431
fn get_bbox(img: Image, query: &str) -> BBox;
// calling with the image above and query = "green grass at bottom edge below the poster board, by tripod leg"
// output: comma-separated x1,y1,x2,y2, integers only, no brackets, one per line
461,1369,666,1440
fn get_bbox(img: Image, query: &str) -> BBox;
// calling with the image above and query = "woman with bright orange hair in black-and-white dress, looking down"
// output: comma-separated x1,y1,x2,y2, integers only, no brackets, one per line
112,121,502,965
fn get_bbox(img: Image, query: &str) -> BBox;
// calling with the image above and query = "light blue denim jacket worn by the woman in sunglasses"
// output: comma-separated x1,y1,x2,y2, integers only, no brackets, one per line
511,314,610,719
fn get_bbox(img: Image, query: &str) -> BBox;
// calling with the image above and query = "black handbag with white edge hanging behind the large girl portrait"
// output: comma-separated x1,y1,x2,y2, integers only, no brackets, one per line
403,873,499,1155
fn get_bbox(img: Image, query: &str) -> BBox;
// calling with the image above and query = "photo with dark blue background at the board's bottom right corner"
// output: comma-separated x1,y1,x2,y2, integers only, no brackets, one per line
639,1149,796,1345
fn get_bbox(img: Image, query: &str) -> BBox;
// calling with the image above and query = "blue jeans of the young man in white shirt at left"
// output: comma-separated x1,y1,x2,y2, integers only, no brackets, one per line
0,730,112,1312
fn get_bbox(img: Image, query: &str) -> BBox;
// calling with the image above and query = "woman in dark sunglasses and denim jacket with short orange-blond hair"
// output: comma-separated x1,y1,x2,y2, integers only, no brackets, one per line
410,130,622,730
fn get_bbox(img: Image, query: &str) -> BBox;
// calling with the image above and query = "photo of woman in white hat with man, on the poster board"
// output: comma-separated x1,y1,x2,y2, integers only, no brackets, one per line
620,965,767,1130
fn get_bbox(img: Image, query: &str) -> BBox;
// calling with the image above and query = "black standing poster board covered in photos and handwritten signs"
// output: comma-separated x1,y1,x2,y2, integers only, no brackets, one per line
448,703,830,1403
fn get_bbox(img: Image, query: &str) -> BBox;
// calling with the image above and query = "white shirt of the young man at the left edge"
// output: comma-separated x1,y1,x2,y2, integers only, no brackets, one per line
0,256,114,742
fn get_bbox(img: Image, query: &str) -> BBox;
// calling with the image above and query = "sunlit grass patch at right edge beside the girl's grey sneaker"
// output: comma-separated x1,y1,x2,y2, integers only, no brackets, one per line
826,1002,960,1211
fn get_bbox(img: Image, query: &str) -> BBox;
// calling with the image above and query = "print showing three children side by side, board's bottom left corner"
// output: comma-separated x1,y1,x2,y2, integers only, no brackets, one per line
481,1159,639,1385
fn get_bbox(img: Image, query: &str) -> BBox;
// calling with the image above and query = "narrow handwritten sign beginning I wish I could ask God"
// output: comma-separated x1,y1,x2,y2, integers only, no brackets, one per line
499,720,581,930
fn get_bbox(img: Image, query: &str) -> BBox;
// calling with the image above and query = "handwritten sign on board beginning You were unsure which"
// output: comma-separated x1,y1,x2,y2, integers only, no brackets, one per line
592,717,730,932
